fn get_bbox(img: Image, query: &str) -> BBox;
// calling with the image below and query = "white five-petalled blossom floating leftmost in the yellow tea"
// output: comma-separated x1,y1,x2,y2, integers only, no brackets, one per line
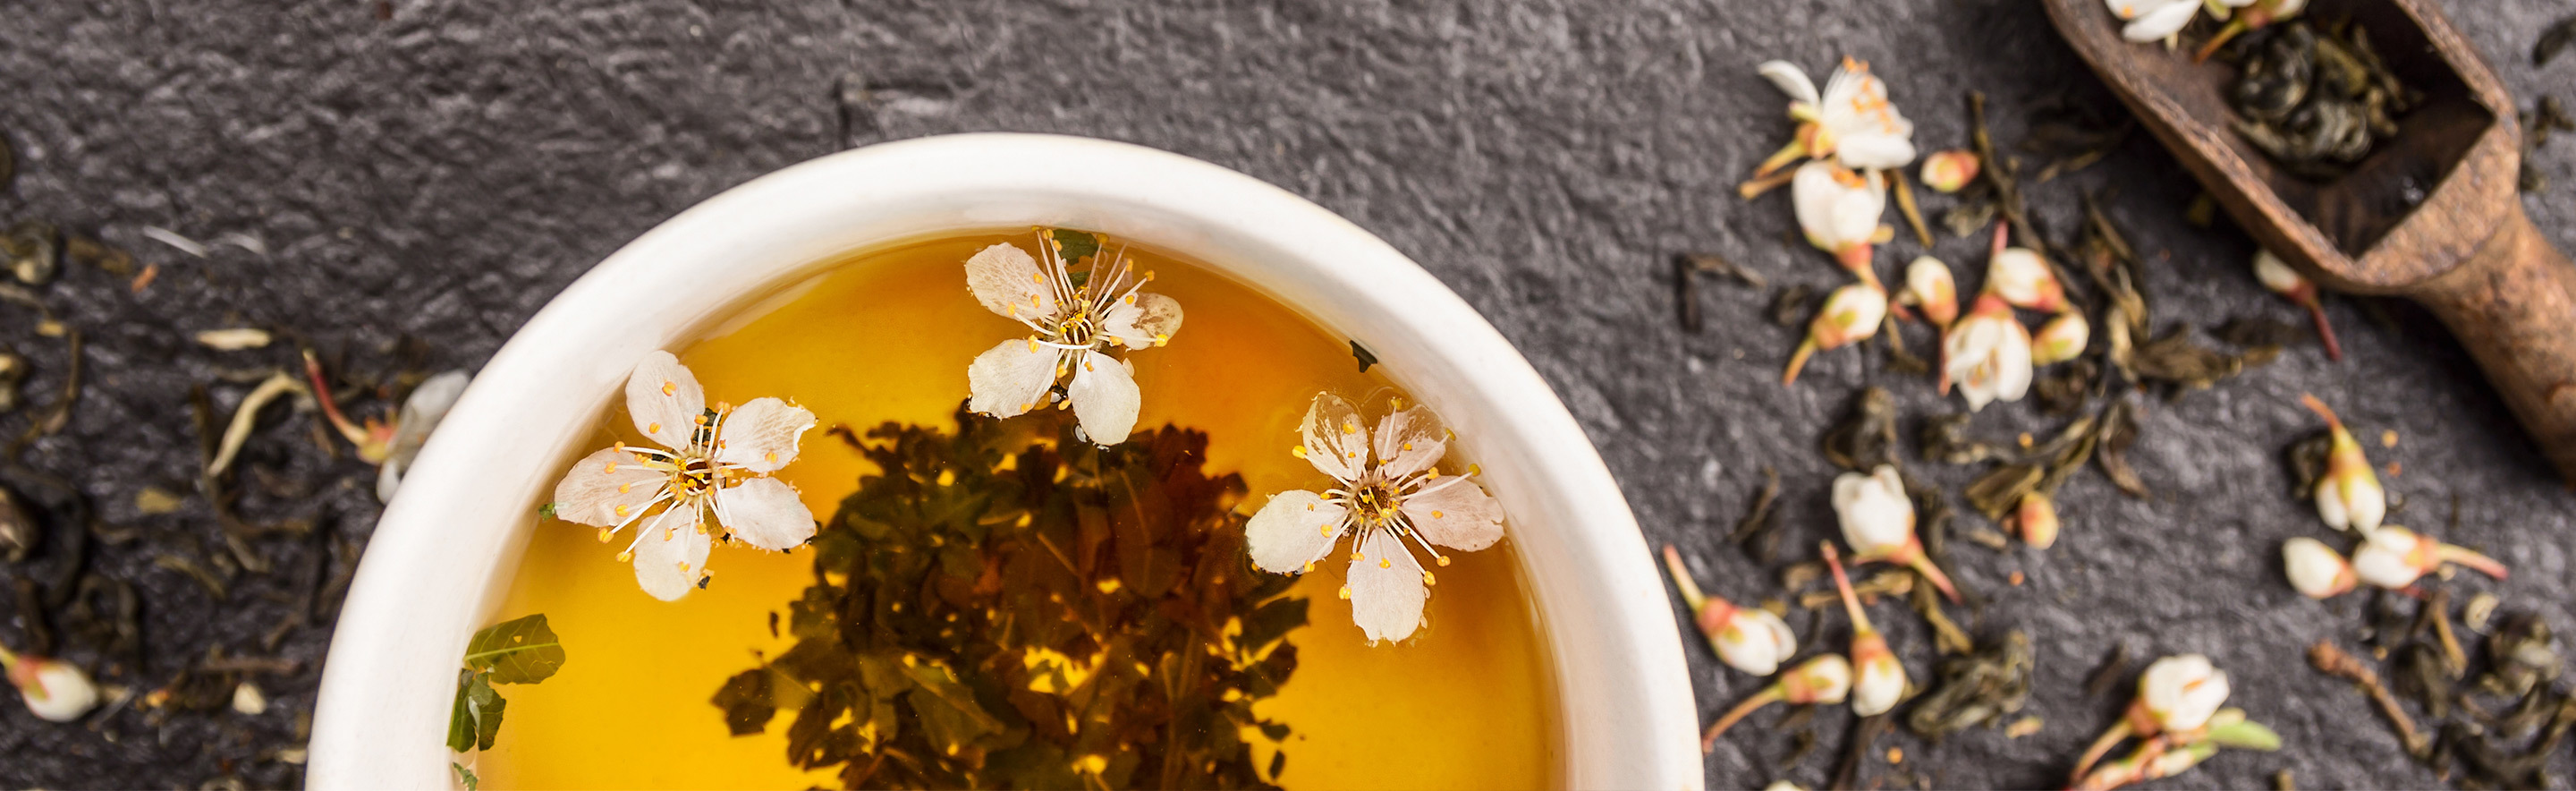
554,351,814,600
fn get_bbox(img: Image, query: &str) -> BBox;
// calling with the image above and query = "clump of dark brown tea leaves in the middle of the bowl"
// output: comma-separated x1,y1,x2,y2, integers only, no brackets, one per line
714,410,1306,788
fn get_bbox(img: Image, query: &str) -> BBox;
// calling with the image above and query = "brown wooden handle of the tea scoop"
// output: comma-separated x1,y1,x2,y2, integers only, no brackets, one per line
2414,201,2576,487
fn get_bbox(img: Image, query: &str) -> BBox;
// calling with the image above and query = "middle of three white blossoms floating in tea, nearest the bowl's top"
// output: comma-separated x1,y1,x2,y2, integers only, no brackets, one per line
966,242,1180,446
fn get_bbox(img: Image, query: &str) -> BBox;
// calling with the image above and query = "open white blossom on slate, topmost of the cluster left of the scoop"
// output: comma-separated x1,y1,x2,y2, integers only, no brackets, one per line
1754,56,1914,178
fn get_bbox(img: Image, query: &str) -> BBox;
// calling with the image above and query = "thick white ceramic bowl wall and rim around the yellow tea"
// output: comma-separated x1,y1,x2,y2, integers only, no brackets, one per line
309,134,1703,788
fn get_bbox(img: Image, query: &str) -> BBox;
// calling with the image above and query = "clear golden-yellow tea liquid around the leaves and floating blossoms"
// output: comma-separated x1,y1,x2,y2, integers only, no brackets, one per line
477,232,1561,788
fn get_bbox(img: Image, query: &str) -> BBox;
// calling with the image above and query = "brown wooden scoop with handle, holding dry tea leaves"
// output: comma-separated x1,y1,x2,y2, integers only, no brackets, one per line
2043,0,2576,487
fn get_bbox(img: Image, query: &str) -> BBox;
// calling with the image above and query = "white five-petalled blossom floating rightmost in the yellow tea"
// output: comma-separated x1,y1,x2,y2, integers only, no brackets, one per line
1244,392,1502,642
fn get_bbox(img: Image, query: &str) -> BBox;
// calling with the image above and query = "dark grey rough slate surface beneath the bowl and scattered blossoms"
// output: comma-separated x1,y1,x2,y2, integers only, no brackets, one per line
0,0,2576,788
